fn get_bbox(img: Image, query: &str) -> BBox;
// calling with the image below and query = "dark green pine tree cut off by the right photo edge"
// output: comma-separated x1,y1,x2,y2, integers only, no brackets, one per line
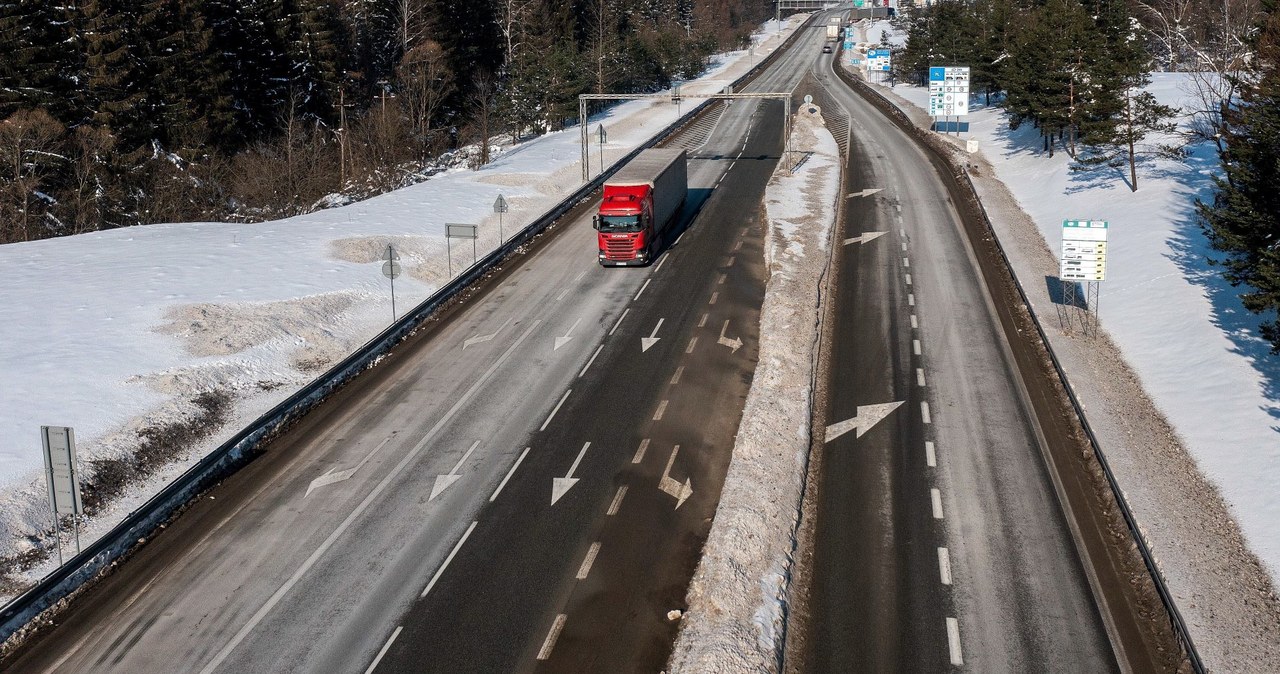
1199,5,1280,353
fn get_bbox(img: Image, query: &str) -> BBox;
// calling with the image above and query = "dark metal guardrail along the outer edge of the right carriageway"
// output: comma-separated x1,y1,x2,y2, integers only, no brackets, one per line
837,68,1206,674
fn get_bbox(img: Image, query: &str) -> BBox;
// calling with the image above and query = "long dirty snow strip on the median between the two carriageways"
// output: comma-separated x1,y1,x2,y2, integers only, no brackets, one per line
671,106,840,674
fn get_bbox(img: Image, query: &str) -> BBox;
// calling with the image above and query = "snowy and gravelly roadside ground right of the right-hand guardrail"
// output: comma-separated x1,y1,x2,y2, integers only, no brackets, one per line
849,22,1280,671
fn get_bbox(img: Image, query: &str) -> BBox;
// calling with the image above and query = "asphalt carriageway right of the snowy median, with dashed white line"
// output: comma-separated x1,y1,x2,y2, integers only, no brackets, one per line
800,43,1117,673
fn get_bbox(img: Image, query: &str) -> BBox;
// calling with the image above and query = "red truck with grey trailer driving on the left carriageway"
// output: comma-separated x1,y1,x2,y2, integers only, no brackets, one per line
594,148,689,266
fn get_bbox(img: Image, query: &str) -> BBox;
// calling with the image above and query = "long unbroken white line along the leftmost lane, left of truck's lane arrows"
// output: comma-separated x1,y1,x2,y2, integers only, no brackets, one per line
200,318,543,674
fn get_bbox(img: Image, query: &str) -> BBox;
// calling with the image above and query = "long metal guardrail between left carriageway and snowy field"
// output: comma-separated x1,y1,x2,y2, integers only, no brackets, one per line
0,17,801,646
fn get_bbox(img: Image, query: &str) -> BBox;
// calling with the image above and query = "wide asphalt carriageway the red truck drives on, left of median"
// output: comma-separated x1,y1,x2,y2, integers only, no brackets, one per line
3,18,817,673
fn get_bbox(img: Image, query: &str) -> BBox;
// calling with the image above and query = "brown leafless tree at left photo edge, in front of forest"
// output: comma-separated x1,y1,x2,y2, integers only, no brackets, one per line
0,109,67,242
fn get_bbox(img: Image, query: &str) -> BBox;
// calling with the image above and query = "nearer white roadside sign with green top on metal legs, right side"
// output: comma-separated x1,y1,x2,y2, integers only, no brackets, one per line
1059,220,1107,336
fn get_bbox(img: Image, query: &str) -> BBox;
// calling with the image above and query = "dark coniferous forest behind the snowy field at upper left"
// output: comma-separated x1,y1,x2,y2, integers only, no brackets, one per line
0,0,772,243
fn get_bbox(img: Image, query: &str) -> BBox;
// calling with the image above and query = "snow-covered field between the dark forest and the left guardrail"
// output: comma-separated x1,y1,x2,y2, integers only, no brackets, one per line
0,15,805,602
